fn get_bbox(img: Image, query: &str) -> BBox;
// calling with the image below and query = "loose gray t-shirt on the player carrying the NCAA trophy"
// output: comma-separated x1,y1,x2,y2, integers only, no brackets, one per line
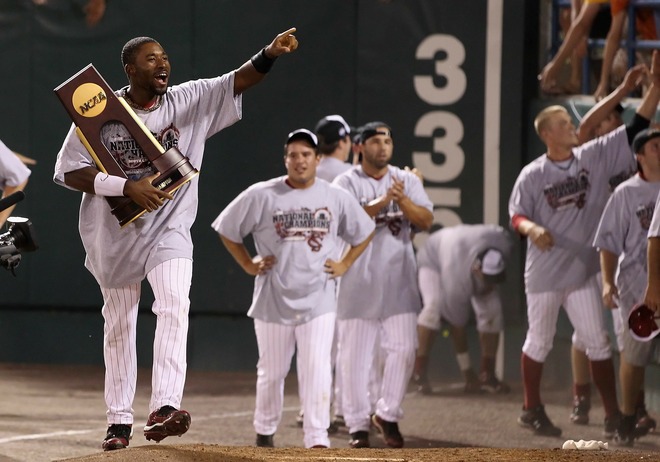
54,71,242,288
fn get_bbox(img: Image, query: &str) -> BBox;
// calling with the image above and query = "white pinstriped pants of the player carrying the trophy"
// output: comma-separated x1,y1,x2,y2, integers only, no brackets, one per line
101,258,192,424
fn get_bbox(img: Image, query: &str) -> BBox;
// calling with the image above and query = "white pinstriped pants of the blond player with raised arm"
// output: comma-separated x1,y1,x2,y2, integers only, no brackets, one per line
523,275,612,363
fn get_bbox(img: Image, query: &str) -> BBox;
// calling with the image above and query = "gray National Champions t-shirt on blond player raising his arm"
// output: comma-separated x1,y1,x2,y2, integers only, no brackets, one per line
509,126,636,293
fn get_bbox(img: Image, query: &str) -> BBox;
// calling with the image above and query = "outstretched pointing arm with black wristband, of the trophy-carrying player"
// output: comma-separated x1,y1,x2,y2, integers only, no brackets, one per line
234,27,298,95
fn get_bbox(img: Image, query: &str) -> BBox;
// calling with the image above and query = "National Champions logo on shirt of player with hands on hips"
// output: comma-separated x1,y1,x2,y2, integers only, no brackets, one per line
273,207,332,252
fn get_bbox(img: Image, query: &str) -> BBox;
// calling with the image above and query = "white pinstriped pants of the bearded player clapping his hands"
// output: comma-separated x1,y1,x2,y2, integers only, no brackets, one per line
338,313,417,433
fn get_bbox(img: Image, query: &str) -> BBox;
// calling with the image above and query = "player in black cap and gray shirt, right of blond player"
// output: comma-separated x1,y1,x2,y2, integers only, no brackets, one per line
594,129,660,446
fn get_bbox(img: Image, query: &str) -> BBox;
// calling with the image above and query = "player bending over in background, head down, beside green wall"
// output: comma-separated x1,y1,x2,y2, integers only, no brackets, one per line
413,224,512,393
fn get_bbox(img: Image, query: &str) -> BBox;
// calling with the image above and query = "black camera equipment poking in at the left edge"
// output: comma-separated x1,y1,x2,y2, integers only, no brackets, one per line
0,191,39,276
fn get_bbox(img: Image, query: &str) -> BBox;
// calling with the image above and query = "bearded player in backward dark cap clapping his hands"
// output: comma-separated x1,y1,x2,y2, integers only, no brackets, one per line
334,122,433,448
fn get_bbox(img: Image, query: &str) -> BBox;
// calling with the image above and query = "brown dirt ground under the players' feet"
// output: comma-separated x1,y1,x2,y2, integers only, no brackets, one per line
0,364,660,462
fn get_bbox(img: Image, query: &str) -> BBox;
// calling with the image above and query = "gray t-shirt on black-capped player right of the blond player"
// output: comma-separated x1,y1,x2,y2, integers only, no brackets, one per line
593,174,660,309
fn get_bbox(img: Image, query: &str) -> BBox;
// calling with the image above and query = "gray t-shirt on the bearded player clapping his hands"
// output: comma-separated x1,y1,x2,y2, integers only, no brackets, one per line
334,165,433,319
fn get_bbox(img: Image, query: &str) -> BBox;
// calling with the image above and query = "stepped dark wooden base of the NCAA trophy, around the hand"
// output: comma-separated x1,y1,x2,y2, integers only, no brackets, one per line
106,147,199,228
